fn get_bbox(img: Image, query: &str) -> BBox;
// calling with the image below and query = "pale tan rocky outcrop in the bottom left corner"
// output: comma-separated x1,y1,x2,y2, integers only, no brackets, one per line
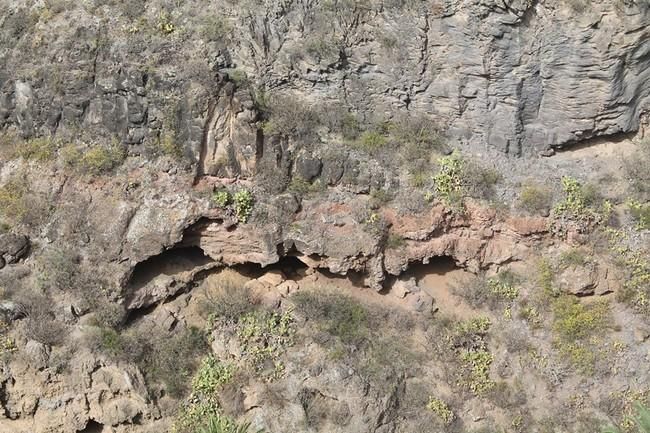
0,352,160,433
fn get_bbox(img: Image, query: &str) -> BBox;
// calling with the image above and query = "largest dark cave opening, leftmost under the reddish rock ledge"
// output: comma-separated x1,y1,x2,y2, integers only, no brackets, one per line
129,246,214,290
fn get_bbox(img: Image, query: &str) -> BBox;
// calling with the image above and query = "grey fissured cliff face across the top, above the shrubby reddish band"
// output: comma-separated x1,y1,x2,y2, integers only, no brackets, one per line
0,0,650,157
